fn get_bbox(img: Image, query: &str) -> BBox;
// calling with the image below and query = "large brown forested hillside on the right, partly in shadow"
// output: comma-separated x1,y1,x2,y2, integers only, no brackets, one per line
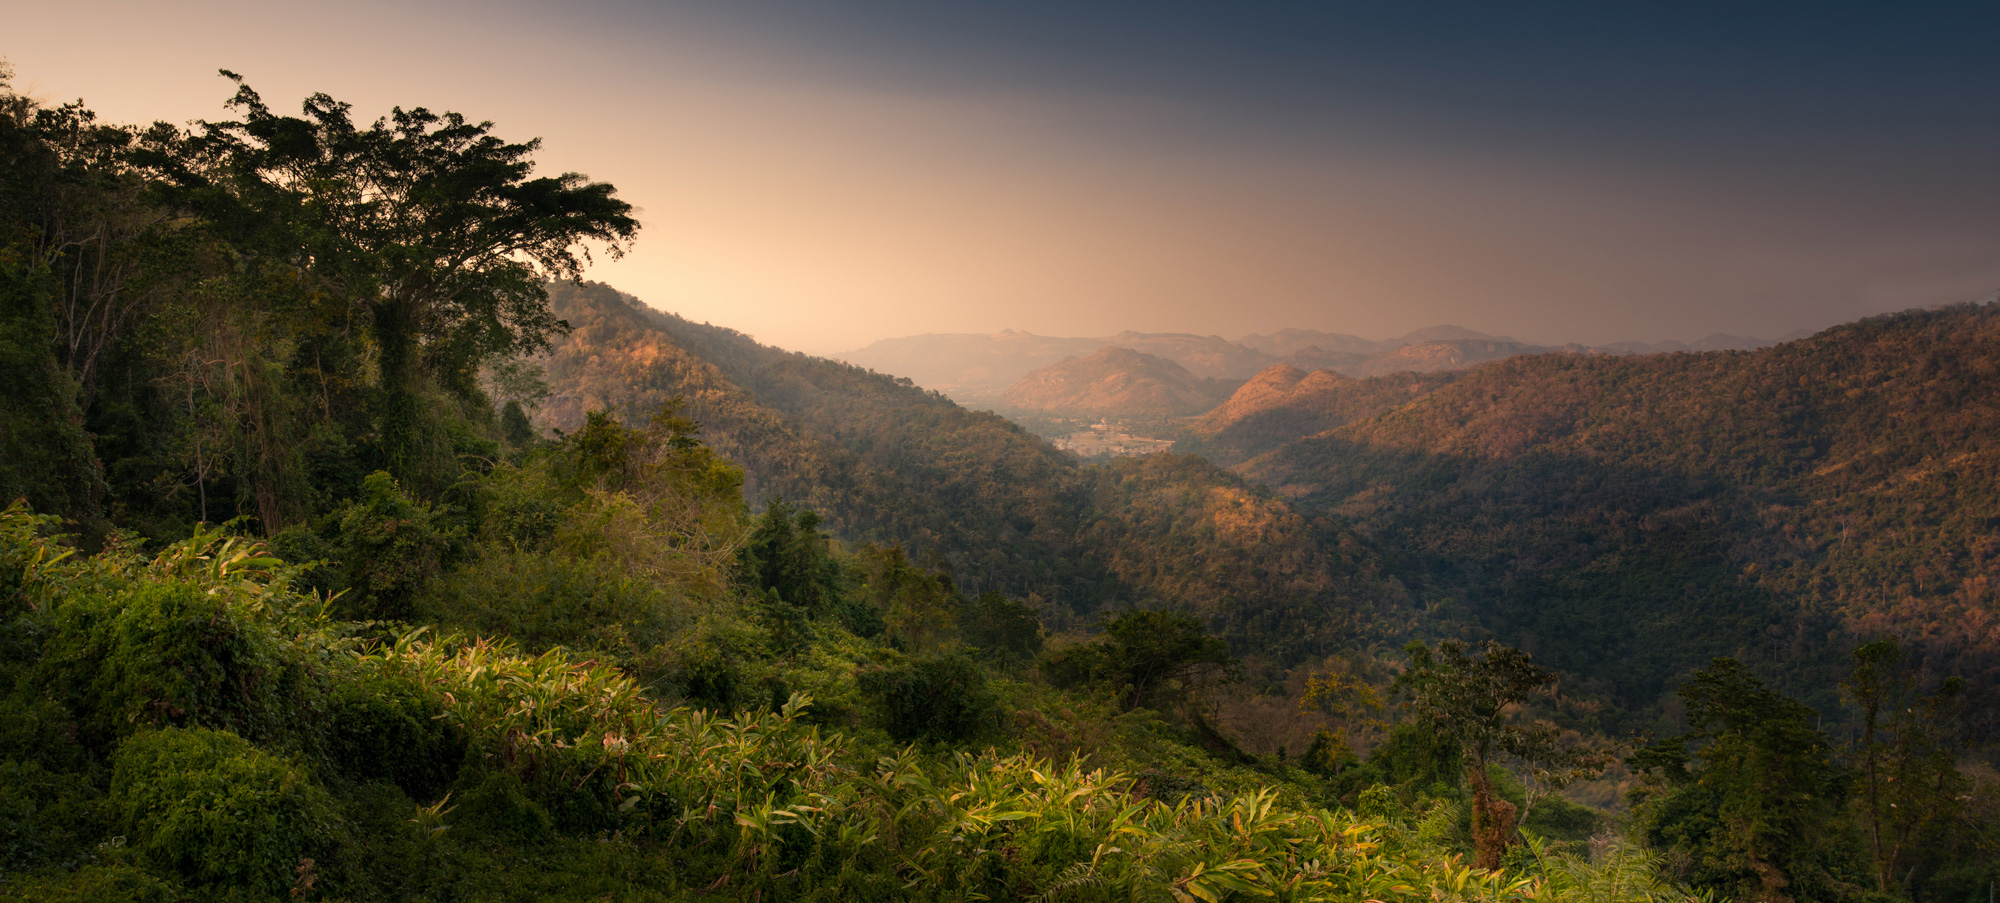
1210,304,2000,727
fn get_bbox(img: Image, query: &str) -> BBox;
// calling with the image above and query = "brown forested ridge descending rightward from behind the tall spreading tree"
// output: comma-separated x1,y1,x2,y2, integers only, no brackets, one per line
544,284,1408,657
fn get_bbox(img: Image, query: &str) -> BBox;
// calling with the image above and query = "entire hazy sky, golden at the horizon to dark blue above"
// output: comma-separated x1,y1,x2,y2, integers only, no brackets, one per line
11,0,2000,352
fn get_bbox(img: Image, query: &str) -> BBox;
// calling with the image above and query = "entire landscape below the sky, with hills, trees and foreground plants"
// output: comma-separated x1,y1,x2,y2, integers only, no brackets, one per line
0,66,2000,903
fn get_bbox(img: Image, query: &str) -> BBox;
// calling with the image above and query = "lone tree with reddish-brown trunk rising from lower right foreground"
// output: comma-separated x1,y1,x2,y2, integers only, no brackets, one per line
1396,639,1602,869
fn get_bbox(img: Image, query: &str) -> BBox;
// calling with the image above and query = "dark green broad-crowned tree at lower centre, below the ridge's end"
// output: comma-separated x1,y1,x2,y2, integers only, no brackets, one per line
1042,611,1242,711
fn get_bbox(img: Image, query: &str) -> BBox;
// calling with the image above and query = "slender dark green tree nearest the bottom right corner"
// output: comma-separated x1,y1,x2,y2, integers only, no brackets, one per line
1840,637,1968,893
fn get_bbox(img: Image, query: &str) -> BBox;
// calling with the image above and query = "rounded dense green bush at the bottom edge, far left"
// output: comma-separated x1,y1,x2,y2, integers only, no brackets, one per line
110,727,338,899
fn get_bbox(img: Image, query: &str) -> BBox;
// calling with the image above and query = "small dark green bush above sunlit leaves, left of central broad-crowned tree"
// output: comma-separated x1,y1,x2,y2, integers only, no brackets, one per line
860,655,1000,743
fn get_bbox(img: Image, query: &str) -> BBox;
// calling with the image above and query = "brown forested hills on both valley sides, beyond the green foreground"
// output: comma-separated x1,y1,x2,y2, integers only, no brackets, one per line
540,284,2000,725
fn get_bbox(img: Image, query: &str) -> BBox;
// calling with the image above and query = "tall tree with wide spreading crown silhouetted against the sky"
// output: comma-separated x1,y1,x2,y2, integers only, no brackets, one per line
140,72,638,477
